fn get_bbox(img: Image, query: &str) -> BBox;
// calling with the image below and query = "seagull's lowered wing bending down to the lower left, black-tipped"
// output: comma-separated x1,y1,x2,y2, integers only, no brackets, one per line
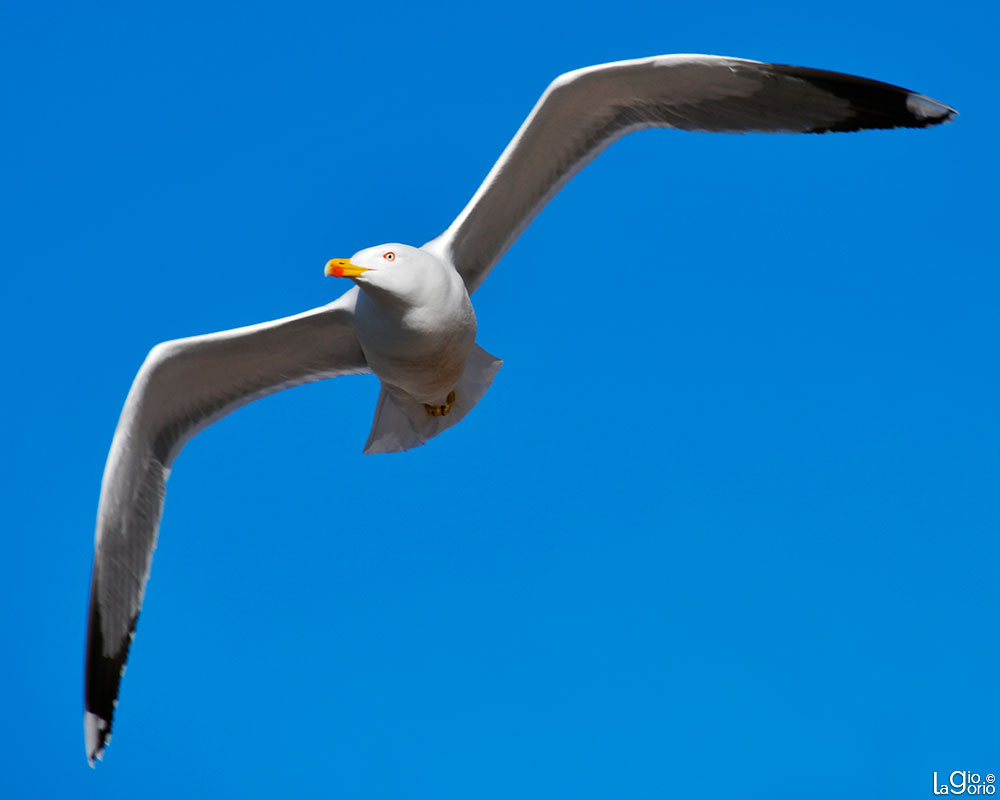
84,289,368,765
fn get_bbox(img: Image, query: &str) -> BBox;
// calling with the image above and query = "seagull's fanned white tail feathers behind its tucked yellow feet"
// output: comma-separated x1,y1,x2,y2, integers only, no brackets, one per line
364,344,503,455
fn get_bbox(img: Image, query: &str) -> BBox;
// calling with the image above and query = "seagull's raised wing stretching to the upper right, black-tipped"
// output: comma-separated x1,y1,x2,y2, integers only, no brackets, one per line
425,55,956,294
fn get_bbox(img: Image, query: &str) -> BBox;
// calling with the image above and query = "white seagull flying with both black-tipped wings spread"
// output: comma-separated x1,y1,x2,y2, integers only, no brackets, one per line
84,54,957,766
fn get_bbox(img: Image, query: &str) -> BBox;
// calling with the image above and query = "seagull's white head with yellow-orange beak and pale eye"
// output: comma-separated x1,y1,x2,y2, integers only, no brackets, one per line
326,243,448,303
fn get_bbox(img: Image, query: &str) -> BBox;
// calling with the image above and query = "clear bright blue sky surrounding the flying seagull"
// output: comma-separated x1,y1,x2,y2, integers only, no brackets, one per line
0,0,1000,800
